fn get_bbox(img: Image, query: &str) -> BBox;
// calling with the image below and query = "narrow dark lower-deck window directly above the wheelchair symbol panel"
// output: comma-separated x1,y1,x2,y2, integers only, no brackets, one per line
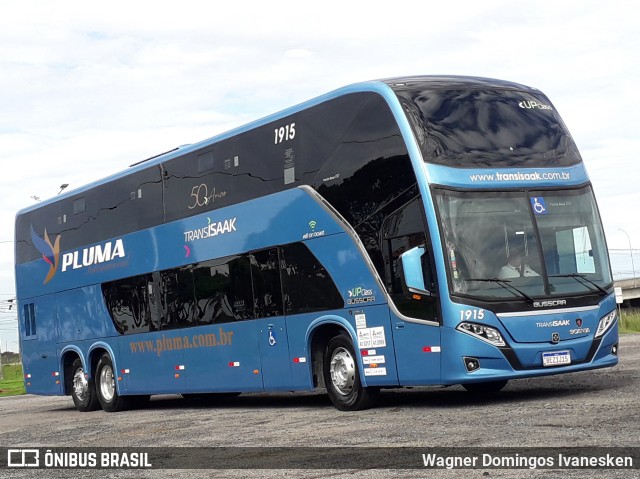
250,248,283,318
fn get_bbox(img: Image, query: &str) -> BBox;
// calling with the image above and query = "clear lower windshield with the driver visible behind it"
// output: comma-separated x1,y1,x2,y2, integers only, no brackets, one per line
435,186,612,300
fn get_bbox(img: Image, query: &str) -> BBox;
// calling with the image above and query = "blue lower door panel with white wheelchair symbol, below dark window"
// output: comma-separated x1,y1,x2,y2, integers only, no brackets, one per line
257,316,291,391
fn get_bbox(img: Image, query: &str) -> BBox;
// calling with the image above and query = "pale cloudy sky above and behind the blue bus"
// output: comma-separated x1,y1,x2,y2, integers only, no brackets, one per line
0,0,640,351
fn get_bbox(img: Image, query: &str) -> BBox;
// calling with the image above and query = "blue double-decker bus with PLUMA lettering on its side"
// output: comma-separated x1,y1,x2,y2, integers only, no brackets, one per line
15,76,618,411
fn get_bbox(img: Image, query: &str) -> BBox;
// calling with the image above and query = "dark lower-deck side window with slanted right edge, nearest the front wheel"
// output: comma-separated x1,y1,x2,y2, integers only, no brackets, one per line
281,243,344,314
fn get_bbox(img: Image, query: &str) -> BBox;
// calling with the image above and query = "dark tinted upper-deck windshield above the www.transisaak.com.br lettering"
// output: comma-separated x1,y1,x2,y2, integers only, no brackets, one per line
402,88,580,168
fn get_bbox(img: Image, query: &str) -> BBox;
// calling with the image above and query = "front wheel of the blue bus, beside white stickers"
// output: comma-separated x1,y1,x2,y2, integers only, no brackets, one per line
323,334,379,411
